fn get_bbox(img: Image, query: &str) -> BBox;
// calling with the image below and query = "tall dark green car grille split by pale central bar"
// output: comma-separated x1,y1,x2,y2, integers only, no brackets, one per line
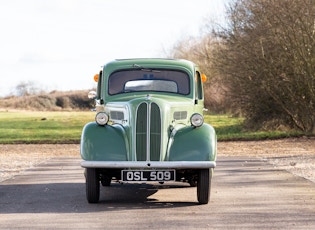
136,102,161,161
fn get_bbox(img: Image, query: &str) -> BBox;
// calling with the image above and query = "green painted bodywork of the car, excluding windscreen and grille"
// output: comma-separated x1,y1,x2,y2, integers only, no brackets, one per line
81,59,216,164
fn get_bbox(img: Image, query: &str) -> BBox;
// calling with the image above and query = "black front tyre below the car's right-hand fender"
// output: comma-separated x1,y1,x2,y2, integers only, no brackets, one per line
197,169,212,204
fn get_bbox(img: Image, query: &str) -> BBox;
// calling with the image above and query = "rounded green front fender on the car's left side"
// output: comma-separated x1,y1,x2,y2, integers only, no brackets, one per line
80,122,128,161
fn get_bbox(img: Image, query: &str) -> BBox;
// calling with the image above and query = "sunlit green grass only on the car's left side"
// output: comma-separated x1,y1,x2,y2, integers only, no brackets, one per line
0,111,95,144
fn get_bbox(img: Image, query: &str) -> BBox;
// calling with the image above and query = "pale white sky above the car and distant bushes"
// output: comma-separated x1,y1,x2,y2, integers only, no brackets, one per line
0,0,227,97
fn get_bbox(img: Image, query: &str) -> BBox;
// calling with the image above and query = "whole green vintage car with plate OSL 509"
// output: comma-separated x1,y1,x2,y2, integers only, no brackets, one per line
80,58,217,204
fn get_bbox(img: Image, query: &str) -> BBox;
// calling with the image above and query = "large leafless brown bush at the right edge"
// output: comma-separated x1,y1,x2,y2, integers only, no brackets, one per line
213,0,315,133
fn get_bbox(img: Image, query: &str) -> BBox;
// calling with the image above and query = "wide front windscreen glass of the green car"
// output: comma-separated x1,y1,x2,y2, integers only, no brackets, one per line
108,69,190,95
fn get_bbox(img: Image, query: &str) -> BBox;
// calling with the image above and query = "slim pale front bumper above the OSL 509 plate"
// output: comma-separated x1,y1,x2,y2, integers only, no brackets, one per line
81,161,216,169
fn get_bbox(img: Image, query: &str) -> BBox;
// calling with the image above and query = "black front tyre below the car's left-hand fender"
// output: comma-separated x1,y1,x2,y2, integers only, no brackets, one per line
85,168,100,203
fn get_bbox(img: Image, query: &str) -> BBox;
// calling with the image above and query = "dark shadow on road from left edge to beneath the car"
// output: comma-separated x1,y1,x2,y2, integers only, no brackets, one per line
0,183,198,214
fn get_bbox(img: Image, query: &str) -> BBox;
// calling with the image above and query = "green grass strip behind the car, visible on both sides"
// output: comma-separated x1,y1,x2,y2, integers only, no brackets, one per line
0,111,301,144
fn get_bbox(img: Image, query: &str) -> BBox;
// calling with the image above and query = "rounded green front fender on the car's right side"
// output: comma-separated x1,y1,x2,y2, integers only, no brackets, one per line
167,124,217,161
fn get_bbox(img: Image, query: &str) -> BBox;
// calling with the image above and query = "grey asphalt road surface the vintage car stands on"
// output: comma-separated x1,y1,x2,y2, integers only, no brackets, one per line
0,157,315,229
